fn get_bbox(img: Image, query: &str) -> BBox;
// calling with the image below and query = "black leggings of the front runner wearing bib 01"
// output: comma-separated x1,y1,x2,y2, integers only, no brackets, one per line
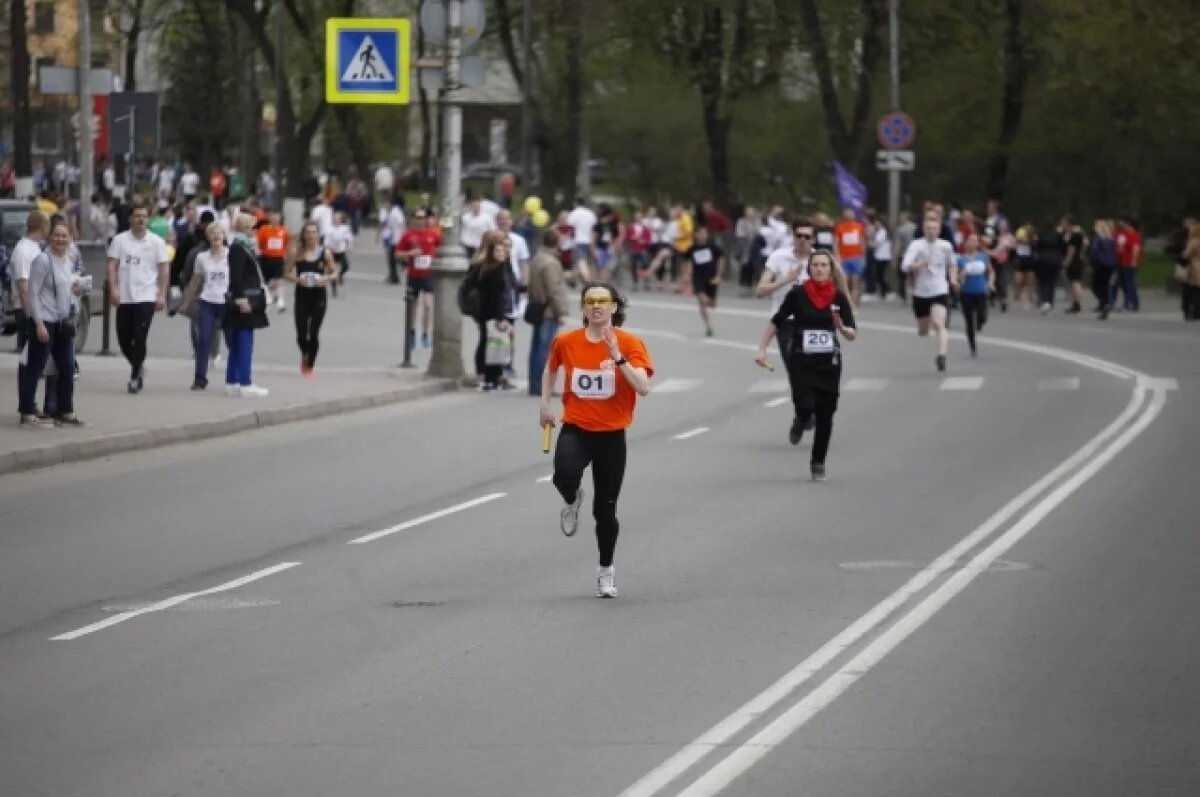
554,424,625,568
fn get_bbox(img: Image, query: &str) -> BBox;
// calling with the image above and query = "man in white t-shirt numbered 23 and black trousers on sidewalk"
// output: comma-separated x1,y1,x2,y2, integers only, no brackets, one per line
108,202,169,394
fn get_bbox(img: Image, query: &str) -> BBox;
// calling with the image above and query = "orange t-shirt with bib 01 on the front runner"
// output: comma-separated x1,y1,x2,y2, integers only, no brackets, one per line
546,329,654,432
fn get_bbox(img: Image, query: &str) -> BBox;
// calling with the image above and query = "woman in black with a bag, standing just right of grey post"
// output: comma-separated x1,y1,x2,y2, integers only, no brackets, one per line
472,229,512,392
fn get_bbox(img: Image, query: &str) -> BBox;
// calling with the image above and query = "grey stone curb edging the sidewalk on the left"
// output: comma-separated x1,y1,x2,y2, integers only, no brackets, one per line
0,379,466,475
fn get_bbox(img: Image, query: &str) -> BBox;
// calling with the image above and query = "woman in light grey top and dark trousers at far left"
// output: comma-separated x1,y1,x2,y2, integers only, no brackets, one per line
19,218,83,429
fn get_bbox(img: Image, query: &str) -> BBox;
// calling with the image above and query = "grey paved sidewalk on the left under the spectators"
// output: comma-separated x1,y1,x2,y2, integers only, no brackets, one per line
0,352,458,474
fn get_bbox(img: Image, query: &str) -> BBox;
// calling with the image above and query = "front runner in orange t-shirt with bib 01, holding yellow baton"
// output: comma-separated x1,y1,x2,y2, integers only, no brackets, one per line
540,283,654,598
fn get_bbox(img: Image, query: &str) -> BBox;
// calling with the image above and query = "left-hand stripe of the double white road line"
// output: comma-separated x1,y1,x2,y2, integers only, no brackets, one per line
620,390,1145,797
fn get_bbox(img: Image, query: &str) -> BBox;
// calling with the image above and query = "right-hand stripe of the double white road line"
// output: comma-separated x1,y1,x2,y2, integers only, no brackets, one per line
679,388,1166,797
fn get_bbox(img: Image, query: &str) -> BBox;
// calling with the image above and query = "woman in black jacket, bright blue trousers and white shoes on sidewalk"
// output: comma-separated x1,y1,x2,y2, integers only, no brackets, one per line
226,214,269,399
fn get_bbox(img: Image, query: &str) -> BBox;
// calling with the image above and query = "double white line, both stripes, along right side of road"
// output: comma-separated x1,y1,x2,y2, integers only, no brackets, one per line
620,381,1169,797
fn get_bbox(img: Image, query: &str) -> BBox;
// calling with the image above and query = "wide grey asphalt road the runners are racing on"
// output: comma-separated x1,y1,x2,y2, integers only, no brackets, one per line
0,250,1200,797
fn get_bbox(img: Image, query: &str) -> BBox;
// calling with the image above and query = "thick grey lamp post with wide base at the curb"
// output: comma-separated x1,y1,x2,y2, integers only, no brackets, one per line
426,0,468,379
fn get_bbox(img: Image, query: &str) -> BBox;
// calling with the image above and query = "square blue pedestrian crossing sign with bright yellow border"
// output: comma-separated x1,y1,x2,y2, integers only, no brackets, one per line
325,17,410,106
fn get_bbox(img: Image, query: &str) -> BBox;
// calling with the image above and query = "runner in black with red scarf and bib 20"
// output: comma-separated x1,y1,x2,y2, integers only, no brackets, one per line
758,251,858,481
